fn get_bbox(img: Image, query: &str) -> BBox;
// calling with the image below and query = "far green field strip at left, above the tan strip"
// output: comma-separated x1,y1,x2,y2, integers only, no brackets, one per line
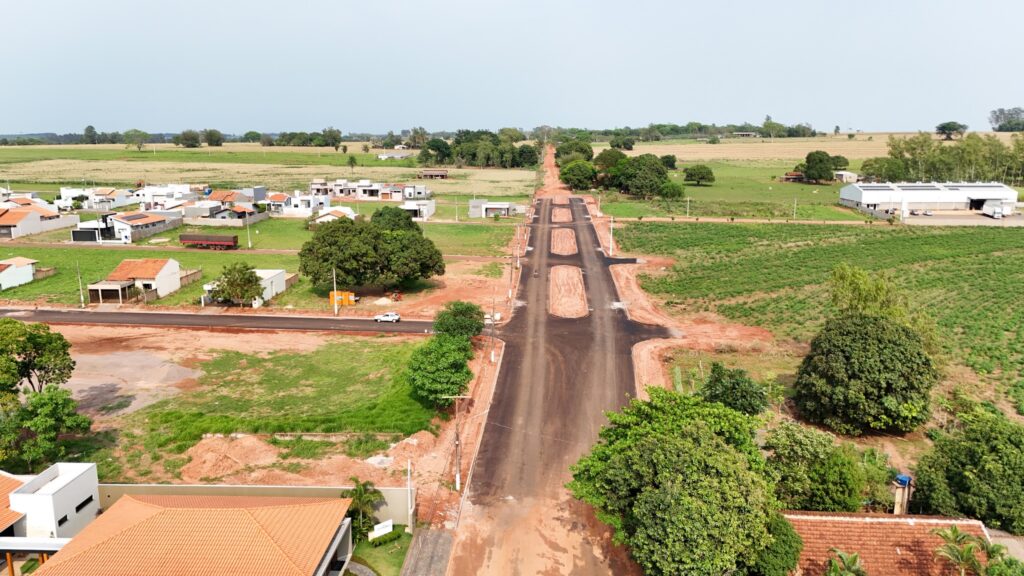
0,145,418,168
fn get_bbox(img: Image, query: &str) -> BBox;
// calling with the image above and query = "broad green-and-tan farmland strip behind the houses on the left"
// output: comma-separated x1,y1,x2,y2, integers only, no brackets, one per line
0,142,537,198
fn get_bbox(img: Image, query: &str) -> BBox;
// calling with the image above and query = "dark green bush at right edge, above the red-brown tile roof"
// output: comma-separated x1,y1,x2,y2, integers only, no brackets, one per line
913,409,1024,534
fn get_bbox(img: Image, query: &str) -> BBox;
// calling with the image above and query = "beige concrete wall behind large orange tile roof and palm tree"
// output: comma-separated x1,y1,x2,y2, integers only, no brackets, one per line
99,484,416,526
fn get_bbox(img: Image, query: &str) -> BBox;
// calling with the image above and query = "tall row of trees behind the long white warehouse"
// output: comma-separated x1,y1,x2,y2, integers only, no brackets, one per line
861,132,1024,184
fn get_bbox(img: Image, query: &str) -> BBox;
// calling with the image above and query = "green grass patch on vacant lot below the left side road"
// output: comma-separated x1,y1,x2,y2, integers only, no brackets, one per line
95,336,434,480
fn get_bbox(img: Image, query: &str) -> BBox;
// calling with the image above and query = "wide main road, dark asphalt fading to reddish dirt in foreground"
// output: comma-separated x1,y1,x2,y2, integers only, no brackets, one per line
449,153,668,575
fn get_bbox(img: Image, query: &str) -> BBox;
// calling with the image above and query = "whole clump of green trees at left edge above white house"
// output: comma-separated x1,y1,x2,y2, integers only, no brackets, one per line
0,318,92,474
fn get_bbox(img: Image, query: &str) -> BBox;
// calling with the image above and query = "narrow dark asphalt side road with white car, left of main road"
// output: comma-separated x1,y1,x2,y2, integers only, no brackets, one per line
0,308,433,333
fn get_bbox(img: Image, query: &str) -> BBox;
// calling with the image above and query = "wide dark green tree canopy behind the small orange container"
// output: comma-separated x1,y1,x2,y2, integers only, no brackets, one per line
299,218,444,290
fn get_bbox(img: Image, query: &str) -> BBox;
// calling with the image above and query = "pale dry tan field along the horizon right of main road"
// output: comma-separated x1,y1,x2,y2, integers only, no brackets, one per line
594,132,1010,162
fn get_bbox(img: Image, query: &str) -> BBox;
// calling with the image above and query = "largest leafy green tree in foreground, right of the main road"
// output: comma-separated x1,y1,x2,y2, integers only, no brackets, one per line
568,421,774,576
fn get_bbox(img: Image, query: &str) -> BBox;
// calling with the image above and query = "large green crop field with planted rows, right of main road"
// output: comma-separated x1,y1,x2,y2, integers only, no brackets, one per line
617,222,1024,383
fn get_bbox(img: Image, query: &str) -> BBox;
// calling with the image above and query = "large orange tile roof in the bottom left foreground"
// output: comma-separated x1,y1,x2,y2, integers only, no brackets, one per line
36,495,350,576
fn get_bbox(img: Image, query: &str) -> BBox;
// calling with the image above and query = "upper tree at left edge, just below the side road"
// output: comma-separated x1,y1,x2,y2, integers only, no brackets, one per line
0,318,75,394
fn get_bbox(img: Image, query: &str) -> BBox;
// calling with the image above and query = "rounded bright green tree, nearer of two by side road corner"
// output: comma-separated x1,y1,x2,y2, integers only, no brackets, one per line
406,334,473,408
